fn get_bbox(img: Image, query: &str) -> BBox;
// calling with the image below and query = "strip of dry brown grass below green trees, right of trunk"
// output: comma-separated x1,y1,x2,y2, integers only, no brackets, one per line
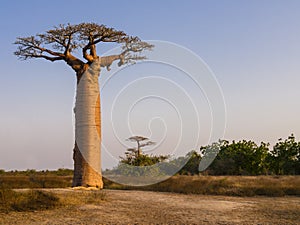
105,175,300,197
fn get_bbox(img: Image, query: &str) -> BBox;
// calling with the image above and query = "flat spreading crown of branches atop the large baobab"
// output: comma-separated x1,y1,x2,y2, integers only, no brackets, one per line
15,23,153,73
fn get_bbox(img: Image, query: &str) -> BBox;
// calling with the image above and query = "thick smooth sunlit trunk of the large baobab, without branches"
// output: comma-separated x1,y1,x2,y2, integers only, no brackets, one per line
73,58,103,188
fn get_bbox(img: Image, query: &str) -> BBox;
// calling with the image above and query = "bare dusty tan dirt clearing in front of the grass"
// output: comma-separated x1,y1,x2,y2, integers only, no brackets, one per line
0,189,300,225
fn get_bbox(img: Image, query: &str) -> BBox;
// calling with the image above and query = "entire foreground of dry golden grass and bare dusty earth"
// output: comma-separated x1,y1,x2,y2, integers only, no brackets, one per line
0,176,300,225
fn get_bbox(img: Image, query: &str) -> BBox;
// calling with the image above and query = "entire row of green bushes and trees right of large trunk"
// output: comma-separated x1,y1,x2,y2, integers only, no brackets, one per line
108,134,300,176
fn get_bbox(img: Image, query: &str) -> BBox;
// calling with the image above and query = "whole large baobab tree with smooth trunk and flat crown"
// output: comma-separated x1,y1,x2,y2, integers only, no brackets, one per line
15,23,153,188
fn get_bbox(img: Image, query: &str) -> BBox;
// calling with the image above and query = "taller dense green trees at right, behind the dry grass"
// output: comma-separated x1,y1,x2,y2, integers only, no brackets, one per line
179,135,300,175
